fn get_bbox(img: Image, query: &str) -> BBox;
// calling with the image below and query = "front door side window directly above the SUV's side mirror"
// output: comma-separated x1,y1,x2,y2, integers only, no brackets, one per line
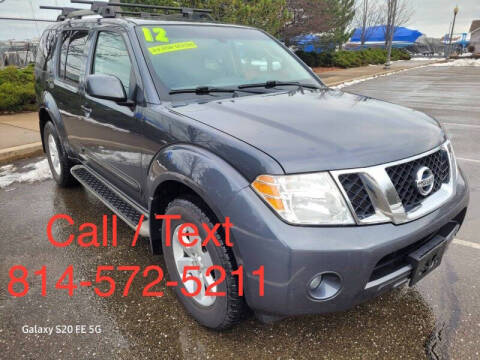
92,32,132,94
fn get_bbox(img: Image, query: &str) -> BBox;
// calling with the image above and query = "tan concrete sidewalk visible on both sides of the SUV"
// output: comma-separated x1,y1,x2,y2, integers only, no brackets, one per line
0,59,439,164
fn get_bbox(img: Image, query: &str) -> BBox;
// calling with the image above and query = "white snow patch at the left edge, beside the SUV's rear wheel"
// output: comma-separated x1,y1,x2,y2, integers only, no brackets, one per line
0,159,52,189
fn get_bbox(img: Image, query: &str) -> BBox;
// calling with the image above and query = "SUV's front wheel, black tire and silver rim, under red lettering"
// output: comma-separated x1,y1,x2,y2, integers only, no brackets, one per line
162,197,247,330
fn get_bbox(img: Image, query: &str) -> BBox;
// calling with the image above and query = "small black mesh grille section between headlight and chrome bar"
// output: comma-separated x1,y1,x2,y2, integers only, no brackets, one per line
338,174,375,220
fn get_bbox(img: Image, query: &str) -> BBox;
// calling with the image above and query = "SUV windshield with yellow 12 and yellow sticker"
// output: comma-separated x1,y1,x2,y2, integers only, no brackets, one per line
137,25,320,97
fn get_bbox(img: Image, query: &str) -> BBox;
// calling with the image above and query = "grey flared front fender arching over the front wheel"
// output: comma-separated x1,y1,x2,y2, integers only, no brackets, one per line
147,144,248,253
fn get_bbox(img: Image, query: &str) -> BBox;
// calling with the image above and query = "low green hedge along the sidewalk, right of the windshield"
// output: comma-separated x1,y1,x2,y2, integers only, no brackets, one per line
297,49,410,68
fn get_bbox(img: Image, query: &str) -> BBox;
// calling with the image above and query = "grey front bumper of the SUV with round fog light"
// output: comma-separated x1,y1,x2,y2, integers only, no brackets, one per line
224,173,469,315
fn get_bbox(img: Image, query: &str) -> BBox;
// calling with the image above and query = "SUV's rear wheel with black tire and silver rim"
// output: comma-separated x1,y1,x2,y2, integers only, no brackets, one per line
43,121,78,187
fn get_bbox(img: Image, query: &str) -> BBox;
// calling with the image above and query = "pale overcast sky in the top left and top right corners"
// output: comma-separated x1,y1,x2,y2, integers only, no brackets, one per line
0,0,480,40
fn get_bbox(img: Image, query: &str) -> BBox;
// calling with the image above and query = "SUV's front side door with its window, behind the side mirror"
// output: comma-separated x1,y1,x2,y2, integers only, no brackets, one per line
82,28,144,202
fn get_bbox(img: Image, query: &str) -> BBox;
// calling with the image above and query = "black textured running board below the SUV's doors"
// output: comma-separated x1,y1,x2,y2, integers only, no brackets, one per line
70,165,150,237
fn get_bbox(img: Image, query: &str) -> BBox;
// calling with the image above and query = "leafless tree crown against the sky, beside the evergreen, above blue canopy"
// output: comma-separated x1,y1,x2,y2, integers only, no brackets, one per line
353,0,383,45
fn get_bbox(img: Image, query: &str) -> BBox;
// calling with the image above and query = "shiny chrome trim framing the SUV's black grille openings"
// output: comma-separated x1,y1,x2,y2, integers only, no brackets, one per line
330,141,457,225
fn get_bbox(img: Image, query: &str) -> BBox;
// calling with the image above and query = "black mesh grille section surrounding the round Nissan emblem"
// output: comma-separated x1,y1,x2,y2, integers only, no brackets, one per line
386,150,450,212
